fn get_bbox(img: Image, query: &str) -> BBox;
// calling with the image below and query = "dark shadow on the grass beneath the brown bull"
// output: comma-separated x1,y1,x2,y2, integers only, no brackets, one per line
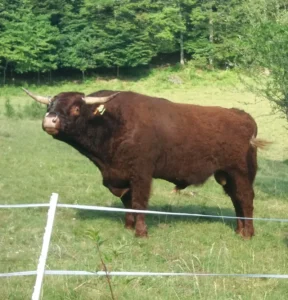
76,202,236,233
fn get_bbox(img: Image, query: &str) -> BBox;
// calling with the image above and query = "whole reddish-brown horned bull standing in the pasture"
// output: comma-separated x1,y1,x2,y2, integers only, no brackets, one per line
25,90,265,237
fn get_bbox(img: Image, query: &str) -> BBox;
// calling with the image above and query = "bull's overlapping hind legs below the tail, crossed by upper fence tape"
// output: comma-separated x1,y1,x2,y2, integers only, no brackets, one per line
223,172,254,238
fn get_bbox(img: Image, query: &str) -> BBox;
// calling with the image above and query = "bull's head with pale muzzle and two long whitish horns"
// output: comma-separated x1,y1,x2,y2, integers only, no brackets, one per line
23,88,118,136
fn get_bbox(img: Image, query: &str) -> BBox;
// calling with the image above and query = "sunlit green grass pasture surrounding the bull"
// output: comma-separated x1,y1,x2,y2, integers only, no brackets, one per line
0,71,288,300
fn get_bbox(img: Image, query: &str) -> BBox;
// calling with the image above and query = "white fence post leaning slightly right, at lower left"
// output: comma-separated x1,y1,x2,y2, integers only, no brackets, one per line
32,193,58,300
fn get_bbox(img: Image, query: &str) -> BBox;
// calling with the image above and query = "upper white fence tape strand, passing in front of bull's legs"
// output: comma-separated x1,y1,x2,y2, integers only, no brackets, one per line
0,203,288,223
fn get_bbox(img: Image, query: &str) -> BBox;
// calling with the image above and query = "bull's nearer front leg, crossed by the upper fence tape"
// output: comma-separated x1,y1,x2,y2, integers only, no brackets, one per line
131,176,152,237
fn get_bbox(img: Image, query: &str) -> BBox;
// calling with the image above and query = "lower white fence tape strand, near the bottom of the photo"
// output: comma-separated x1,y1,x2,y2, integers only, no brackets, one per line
0,270,288,279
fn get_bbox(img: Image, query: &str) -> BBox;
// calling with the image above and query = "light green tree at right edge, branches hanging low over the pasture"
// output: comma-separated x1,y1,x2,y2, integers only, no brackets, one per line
238,0,288,120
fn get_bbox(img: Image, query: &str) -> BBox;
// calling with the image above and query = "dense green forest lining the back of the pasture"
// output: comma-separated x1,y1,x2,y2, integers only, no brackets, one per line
0,0,288,84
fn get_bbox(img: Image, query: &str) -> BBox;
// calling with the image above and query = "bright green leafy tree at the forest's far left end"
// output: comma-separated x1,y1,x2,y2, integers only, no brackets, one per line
0,2,58,83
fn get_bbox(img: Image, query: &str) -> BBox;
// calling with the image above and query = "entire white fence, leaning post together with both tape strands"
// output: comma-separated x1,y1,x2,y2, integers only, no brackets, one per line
0,193,288,292
